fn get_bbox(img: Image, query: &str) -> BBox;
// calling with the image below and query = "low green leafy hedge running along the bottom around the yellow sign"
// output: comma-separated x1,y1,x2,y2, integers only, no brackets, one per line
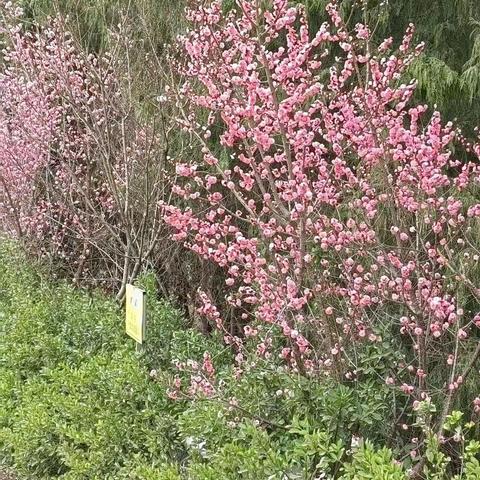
0,242,480,480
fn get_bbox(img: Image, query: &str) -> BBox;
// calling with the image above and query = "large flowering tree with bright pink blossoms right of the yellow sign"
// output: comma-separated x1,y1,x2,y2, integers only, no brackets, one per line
164,0,480,454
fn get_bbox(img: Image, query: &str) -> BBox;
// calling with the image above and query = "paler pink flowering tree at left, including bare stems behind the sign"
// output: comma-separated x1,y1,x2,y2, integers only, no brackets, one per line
0,2,176,299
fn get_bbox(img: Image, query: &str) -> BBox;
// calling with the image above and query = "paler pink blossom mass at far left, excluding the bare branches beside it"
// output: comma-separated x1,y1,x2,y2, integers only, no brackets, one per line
0,6,118,258
